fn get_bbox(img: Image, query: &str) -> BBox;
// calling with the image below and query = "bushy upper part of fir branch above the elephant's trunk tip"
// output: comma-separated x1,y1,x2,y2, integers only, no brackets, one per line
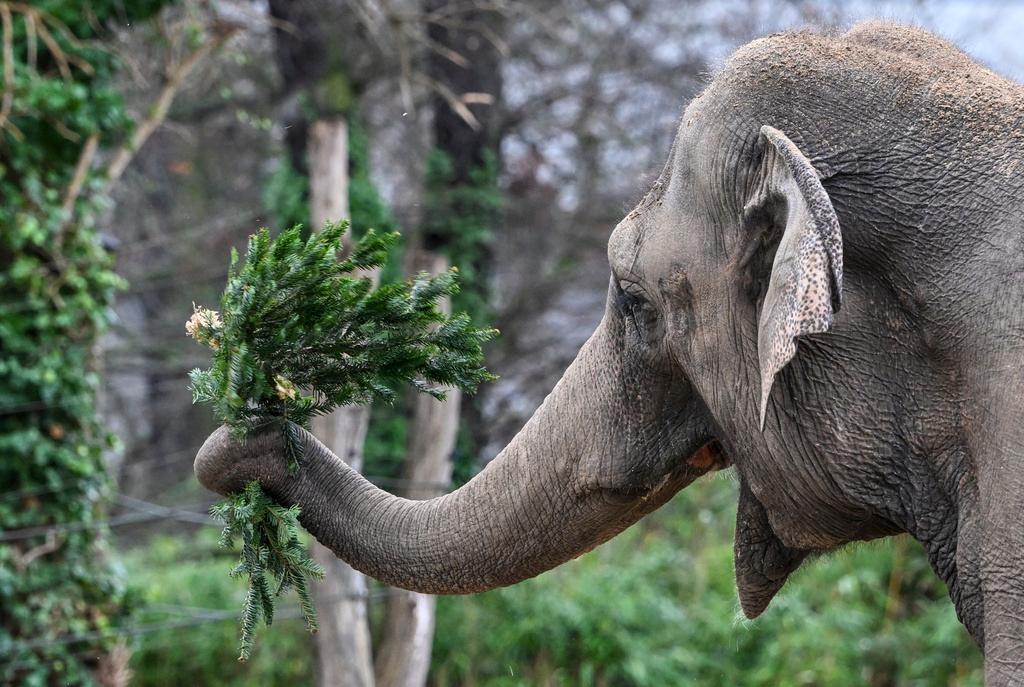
186,222,495,448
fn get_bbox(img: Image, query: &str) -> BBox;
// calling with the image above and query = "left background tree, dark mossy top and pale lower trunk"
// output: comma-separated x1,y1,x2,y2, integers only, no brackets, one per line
268,0,377,675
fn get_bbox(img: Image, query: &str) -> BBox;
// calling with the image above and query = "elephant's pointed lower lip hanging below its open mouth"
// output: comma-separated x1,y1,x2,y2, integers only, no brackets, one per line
734,481,809,619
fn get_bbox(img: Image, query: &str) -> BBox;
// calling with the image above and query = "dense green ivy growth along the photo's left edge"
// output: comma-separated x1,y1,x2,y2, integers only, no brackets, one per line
0,0,165,685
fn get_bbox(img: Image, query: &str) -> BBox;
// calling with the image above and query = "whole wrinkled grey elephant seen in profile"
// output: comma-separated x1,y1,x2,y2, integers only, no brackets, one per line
196,23,1024,685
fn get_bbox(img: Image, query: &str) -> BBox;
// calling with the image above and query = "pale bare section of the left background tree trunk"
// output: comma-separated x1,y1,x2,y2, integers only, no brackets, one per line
307,117,376,687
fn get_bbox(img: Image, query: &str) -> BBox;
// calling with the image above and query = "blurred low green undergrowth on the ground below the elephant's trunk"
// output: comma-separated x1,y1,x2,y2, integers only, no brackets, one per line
125,476,982,687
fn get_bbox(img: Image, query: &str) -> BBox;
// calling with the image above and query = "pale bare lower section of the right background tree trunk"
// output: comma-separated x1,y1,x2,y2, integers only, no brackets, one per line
374,250,462,687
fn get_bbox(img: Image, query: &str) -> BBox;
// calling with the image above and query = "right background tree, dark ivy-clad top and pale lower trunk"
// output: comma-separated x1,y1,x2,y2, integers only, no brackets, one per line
375,0,505,687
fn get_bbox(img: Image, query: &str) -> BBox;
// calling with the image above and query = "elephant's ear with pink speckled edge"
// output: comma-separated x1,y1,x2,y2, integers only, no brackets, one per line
748,126,843,429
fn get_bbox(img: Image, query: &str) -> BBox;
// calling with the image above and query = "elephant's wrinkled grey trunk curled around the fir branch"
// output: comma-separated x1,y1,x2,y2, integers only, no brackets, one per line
196,323,707,594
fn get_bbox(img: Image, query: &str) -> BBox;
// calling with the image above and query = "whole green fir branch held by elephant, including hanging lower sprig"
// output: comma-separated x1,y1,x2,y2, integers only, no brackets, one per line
185,222,497,659
